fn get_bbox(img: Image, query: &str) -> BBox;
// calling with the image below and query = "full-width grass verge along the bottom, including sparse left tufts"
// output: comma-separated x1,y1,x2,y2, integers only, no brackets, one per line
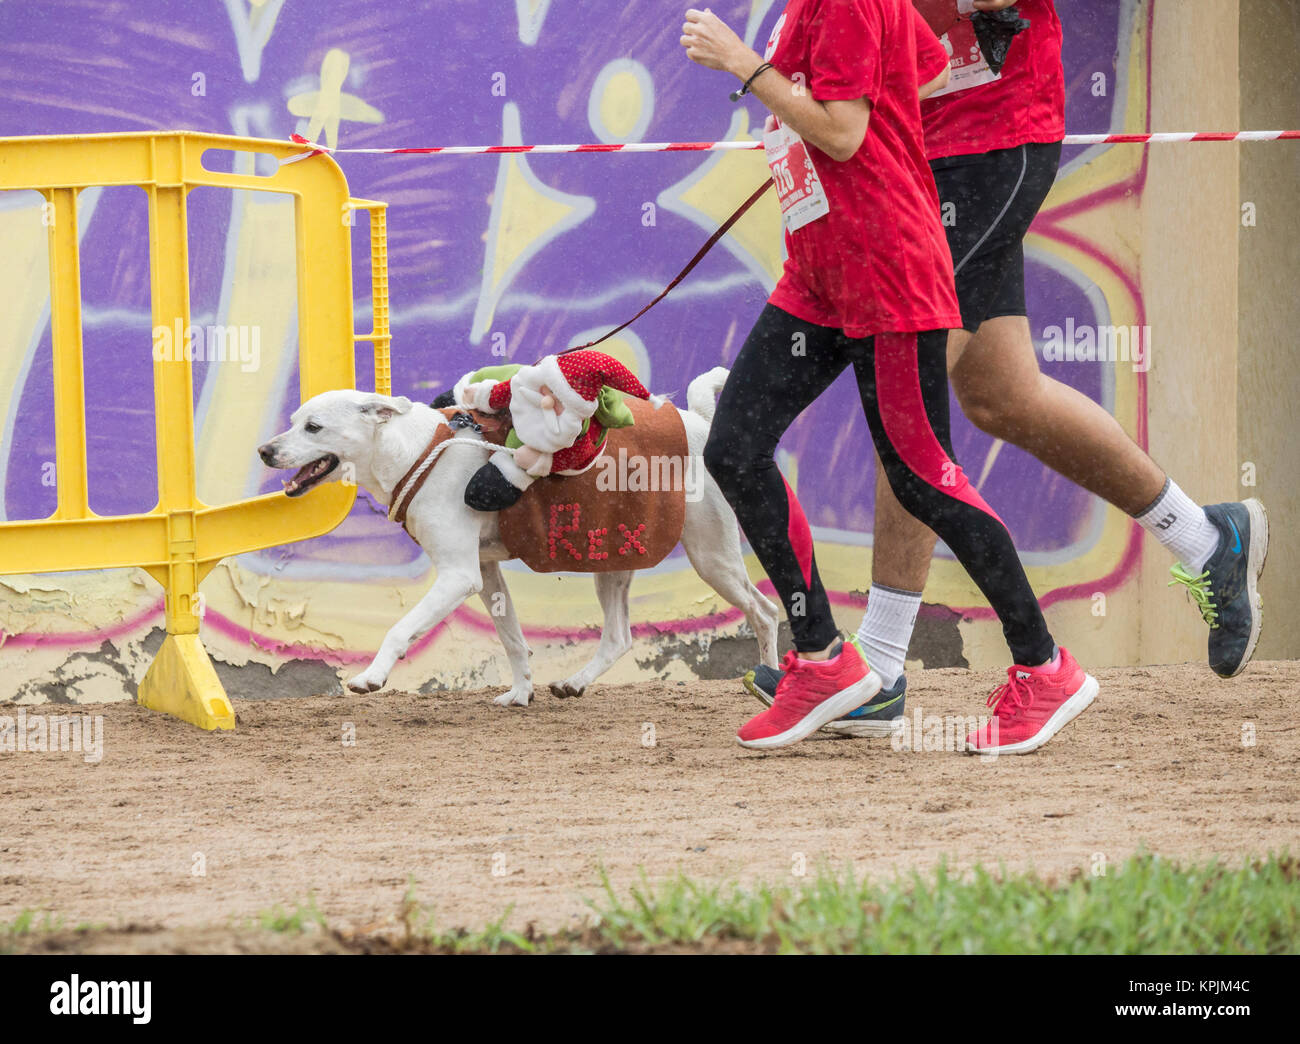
0,854,1300,954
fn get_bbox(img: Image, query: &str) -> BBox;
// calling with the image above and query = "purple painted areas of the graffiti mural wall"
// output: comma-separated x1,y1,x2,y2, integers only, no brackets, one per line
0,0,1132,621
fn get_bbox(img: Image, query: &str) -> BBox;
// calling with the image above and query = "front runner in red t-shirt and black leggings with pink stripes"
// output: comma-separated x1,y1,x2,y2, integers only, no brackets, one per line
681,0,1097,749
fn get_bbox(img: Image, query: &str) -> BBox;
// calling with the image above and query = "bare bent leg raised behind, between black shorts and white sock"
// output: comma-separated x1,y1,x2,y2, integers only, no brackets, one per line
948,316,1165,515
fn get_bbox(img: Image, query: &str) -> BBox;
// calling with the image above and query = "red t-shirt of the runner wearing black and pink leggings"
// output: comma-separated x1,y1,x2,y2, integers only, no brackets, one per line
767,0,961,337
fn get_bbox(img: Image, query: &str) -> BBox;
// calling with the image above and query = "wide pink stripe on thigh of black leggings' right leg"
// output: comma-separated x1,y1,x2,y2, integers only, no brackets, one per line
876,334,1006,527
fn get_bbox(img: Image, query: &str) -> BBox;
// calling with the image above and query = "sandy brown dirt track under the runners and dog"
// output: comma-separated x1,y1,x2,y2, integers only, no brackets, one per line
0,662,1300,945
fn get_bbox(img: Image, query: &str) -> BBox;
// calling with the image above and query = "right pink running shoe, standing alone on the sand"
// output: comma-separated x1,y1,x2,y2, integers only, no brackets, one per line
966,649,1097,754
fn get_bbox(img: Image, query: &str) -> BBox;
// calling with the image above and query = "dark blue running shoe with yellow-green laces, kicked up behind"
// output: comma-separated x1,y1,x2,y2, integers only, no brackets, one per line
1169,498,1269,677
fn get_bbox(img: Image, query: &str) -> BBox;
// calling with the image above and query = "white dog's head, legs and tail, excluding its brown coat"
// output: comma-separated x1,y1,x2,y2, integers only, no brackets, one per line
257,367,777,706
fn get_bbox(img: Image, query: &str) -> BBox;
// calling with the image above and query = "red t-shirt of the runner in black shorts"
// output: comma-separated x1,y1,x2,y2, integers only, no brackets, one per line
920,0,1065,160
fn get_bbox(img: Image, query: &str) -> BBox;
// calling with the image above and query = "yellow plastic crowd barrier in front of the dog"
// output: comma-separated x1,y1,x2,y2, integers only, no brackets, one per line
0,131,391,729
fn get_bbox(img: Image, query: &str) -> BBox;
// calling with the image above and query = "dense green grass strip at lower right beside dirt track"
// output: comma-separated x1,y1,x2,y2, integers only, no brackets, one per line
574,855,1300,954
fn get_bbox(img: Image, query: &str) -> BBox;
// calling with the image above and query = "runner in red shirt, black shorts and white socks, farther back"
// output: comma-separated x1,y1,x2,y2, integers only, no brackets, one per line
806,0,1268,748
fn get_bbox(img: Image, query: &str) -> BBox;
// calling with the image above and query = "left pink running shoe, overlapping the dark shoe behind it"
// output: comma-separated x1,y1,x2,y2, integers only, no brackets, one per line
736,642,880,750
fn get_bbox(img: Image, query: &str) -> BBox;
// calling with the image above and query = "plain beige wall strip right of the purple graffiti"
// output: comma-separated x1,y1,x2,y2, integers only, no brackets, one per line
1139,0,1247,663
